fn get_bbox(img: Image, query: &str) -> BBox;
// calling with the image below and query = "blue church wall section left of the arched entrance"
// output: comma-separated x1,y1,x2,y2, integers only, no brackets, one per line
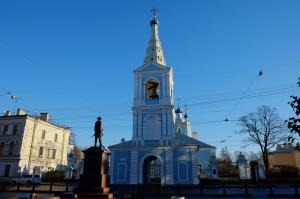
113,151,131,184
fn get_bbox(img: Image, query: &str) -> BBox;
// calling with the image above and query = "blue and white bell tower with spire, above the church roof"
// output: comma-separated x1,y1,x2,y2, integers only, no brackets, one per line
132,9,175,146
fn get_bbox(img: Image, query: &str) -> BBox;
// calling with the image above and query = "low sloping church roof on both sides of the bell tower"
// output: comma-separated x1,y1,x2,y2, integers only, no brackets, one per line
109,133,216,149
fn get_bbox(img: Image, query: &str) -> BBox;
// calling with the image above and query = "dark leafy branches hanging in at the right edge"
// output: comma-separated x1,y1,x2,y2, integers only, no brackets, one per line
288,78,300,150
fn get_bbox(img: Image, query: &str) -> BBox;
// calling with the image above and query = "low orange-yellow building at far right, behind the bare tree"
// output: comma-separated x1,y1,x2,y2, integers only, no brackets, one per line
268,144,300,169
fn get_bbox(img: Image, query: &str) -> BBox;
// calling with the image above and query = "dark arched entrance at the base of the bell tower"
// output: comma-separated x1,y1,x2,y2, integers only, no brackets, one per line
143,156,161,184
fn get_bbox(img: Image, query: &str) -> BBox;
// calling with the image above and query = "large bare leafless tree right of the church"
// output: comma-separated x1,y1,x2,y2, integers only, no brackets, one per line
239,106,287,176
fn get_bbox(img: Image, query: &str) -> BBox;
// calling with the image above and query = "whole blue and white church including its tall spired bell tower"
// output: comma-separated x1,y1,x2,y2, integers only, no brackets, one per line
109,15,218,184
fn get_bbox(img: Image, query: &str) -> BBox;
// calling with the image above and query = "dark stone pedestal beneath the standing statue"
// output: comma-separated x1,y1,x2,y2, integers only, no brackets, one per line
74,147,113,199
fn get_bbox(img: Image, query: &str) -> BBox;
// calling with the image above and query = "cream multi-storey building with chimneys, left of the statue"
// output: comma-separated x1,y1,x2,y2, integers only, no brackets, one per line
0,109,71,177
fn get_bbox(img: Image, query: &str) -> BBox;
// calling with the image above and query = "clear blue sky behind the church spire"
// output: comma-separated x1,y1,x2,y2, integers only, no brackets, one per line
0,0,300,155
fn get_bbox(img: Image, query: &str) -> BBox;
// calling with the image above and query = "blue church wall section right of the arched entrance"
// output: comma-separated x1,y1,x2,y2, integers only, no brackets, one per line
173,149,193,184
